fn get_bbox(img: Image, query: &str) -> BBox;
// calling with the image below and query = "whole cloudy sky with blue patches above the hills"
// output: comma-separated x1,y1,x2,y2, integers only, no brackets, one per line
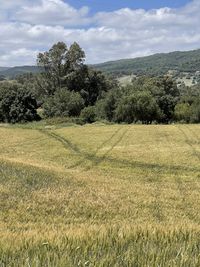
0,0,200,66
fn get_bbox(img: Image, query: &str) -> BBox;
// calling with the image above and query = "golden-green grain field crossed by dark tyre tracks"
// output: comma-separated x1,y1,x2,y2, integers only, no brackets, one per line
0,124,200,267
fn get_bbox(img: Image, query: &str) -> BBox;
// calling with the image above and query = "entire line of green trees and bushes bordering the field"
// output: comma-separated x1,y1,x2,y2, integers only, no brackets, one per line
0,42,200,124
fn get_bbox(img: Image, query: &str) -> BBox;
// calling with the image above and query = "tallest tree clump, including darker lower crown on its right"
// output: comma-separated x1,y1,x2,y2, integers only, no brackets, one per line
37,42,113,106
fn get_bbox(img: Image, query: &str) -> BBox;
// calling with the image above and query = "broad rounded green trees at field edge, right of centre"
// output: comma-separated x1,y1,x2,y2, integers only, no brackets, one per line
96,77,180,123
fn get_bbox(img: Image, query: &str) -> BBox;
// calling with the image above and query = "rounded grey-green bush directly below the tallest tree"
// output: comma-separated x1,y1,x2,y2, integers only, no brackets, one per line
43,88,84,117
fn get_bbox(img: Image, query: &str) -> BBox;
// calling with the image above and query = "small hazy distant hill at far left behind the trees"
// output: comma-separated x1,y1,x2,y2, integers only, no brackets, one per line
0,66,40,78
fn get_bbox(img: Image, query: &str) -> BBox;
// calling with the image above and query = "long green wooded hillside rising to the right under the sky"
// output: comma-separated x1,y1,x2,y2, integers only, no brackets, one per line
94,49,200,75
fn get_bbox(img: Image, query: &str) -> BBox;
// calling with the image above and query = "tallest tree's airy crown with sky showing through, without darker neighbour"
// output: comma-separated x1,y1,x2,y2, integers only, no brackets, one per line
37,42,85,95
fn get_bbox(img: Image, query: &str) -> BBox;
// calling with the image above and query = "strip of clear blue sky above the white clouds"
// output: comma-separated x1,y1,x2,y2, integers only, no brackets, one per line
65,0,190,13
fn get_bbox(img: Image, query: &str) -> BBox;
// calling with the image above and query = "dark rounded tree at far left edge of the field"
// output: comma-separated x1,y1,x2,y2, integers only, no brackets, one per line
0,83,39,123
